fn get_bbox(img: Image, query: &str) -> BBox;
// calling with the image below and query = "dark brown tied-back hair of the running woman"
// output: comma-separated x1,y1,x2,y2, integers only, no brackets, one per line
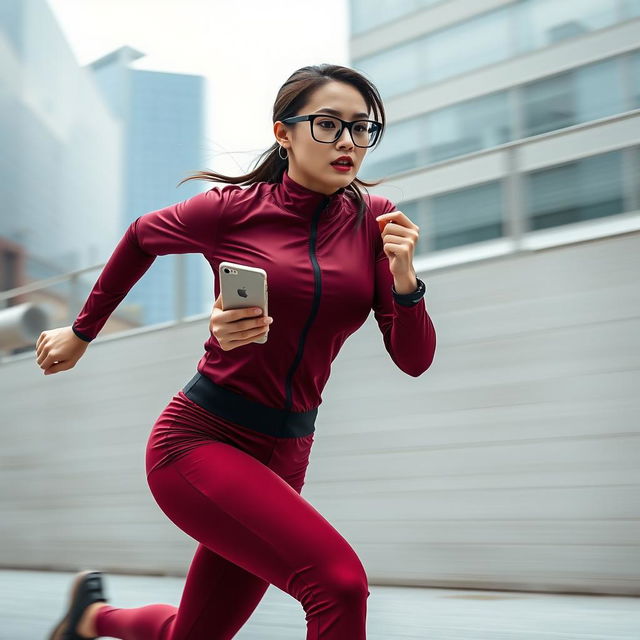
178,64,386,226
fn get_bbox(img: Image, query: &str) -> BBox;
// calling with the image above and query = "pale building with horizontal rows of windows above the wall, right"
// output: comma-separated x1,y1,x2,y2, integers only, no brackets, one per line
351,0,640,256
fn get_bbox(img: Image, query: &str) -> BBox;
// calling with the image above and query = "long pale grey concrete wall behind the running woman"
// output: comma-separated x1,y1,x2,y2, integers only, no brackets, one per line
0,233,640,594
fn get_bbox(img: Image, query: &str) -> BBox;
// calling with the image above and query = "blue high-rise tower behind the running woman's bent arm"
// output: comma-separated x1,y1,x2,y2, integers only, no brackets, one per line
89,46,208,325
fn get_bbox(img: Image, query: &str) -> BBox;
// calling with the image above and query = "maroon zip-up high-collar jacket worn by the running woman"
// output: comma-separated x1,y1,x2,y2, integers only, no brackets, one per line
73,171,436,411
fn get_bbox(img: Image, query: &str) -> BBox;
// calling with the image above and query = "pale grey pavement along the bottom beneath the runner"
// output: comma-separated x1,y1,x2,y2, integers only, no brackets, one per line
0,567,640,640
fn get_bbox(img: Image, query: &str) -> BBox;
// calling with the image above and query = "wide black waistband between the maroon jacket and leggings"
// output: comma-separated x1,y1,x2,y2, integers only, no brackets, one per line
182,371,318,438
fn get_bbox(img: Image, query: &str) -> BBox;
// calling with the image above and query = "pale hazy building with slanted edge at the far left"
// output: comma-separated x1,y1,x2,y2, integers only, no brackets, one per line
0,0,123,282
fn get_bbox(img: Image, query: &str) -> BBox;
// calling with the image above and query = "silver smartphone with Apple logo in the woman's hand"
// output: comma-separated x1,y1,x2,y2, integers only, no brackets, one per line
218,261,269,344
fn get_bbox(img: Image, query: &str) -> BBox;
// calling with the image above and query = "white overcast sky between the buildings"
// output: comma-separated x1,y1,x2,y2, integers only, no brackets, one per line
47,0,349,175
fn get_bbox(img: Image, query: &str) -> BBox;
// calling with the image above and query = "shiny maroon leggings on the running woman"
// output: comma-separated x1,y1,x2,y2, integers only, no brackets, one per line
96,391,370,640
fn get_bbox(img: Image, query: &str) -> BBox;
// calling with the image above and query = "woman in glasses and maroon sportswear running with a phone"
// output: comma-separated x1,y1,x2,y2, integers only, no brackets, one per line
36,64,436,640
